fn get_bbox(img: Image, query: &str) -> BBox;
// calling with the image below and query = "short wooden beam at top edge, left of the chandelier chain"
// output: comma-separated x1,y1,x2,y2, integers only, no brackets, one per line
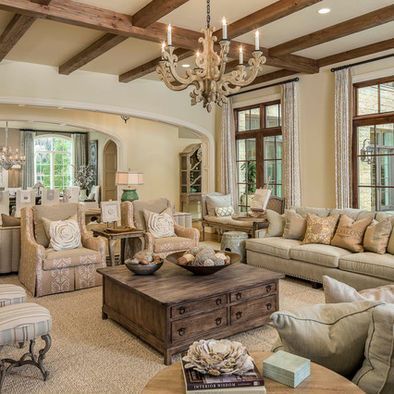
133,0,189,28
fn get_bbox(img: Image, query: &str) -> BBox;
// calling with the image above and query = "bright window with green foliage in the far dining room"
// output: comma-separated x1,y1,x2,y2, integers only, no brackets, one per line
34,135,72,189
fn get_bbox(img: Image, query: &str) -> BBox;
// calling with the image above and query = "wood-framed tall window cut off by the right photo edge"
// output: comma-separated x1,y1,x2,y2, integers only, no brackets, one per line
353,76,394,211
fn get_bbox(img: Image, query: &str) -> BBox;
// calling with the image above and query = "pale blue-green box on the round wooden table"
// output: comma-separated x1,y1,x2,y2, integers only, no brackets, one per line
263,350,311,388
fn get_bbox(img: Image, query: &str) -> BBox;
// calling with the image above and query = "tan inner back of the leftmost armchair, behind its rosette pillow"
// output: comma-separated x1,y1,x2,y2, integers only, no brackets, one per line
32,203,78,248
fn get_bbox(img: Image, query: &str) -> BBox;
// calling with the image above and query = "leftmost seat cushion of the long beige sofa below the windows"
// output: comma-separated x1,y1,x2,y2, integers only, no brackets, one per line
246,237,301,260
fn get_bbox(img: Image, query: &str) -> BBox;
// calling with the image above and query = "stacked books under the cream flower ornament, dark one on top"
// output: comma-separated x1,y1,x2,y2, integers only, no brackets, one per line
182,360,266,394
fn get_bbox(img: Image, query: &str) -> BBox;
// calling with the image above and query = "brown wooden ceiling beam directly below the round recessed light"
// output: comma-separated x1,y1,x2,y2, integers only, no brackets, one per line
270,5,394,56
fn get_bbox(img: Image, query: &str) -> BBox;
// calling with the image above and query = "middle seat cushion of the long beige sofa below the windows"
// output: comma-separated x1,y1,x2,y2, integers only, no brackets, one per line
290,244,349,268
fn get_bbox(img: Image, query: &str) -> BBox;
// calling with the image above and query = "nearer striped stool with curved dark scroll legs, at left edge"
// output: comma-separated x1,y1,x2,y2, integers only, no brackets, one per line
0,303,52,392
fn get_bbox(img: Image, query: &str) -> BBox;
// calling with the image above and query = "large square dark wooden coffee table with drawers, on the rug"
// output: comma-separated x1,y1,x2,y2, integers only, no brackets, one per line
97,262,284,365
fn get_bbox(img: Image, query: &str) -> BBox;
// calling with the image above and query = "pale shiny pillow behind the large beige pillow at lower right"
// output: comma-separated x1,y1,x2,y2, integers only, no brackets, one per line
323,275,394,304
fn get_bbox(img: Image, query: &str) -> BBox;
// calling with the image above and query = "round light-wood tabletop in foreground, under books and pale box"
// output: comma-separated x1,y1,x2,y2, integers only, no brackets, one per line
142,352,363,394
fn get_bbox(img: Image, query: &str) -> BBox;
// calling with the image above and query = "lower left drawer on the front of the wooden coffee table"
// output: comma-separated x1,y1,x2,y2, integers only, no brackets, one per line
171,308,228,342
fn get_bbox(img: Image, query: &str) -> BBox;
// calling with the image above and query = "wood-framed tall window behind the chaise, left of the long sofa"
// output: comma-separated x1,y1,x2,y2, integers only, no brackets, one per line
235,101,282,212
